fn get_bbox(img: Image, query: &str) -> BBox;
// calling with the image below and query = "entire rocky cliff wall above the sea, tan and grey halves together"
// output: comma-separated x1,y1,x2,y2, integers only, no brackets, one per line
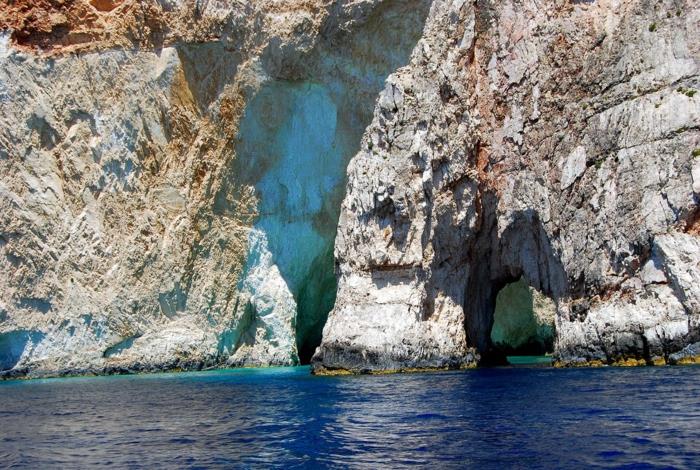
0,0,700,376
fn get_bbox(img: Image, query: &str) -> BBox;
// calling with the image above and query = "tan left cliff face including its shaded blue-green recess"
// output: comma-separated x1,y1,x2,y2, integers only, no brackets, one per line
0,0,429,376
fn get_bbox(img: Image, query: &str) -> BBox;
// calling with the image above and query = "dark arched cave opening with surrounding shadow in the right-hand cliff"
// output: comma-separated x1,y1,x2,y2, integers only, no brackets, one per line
464,193,567,366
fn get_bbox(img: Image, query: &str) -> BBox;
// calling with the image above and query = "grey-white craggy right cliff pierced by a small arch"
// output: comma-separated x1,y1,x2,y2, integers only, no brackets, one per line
313,0,700,373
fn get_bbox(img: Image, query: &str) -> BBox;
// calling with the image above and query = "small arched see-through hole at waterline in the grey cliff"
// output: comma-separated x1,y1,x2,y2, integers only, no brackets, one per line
490,277,556,365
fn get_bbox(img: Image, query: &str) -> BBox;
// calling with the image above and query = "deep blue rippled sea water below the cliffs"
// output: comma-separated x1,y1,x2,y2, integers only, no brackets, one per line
0,367,700,469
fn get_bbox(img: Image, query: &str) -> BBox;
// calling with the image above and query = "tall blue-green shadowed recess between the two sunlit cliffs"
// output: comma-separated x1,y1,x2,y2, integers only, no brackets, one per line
215,0,431,363
